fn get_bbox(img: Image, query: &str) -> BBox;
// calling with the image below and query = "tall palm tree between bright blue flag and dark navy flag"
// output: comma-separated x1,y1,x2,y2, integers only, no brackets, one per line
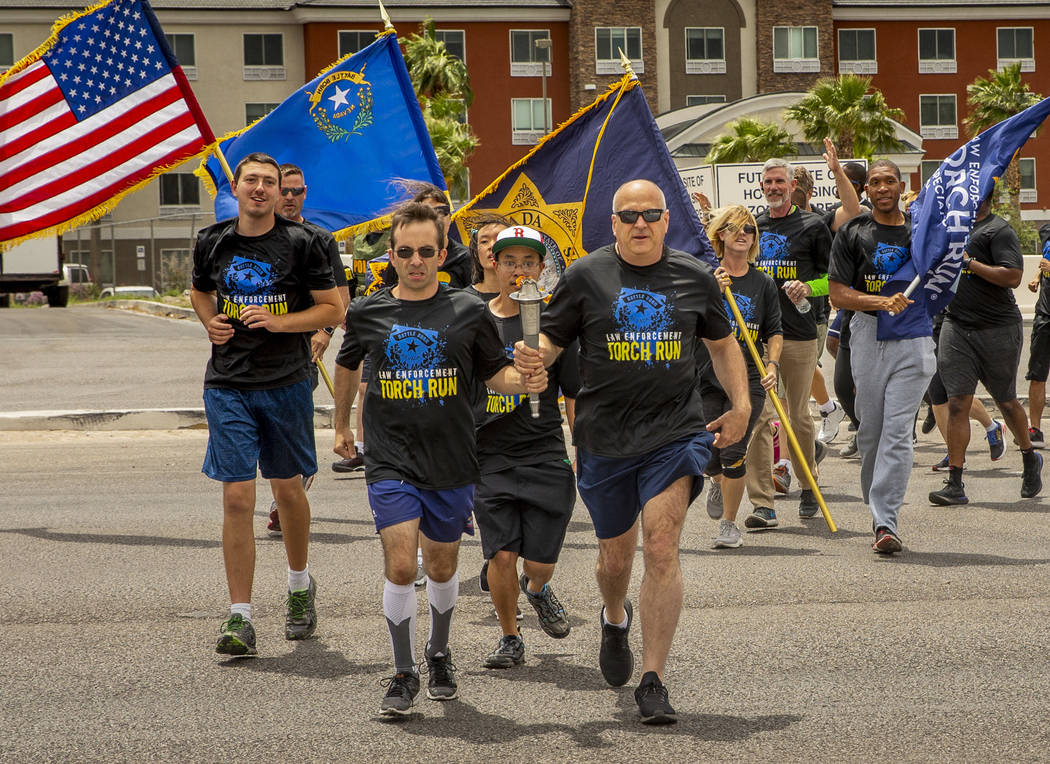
404,18,480,199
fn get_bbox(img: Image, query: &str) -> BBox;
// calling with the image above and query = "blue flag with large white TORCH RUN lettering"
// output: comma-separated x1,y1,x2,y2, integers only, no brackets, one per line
878,99,1050,340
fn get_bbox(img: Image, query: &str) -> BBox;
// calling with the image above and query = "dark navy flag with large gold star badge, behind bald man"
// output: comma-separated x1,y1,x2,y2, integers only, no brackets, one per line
454,76,717,290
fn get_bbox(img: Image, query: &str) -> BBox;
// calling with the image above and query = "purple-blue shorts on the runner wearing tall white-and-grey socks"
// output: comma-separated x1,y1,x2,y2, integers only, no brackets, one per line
369,481,474,544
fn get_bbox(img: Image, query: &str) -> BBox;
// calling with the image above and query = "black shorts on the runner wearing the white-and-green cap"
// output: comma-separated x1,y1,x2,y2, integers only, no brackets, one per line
474,459,576,565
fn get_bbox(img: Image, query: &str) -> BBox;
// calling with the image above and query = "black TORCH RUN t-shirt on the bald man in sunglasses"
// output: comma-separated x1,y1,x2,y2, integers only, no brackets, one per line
542,245,732,458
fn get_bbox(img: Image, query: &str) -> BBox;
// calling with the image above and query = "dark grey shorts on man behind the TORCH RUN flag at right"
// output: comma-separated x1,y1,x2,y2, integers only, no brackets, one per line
937,318,1024,403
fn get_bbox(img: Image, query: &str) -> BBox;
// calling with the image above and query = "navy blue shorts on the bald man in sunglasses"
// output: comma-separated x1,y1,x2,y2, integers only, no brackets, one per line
576,430,714,538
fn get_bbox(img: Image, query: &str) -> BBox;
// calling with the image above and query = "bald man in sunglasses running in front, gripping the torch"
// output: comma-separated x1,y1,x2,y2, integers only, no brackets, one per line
515,179,751,724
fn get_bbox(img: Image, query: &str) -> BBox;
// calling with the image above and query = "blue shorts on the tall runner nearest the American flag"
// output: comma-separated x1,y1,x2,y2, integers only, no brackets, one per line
201,379,317,483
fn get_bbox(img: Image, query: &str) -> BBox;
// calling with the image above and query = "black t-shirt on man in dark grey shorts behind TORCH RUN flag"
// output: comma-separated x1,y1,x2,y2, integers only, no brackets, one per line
947,215,1025,328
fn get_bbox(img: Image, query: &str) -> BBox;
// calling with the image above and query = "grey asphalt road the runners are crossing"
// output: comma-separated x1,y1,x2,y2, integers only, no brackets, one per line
0,307,1050,762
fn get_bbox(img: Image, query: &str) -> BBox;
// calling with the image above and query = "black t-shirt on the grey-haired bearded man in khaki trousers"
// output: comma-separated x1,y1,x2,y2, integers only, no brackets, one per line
755,208,832,340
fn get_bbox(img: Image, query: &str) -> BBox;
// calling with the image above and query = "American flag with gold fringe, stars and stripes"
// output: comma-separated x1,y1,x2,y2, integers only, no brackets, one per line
0,0,215,241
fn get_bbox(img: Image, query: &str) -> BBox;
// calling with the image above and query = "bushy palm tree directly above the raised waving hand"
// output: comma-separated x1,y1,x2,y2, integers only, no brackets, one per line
784,75,904,160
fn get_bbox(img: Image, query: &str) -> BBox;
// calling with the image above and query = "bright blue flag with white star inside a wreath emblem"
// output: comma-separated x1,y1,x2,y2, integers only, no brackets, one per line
197,33,445,238
